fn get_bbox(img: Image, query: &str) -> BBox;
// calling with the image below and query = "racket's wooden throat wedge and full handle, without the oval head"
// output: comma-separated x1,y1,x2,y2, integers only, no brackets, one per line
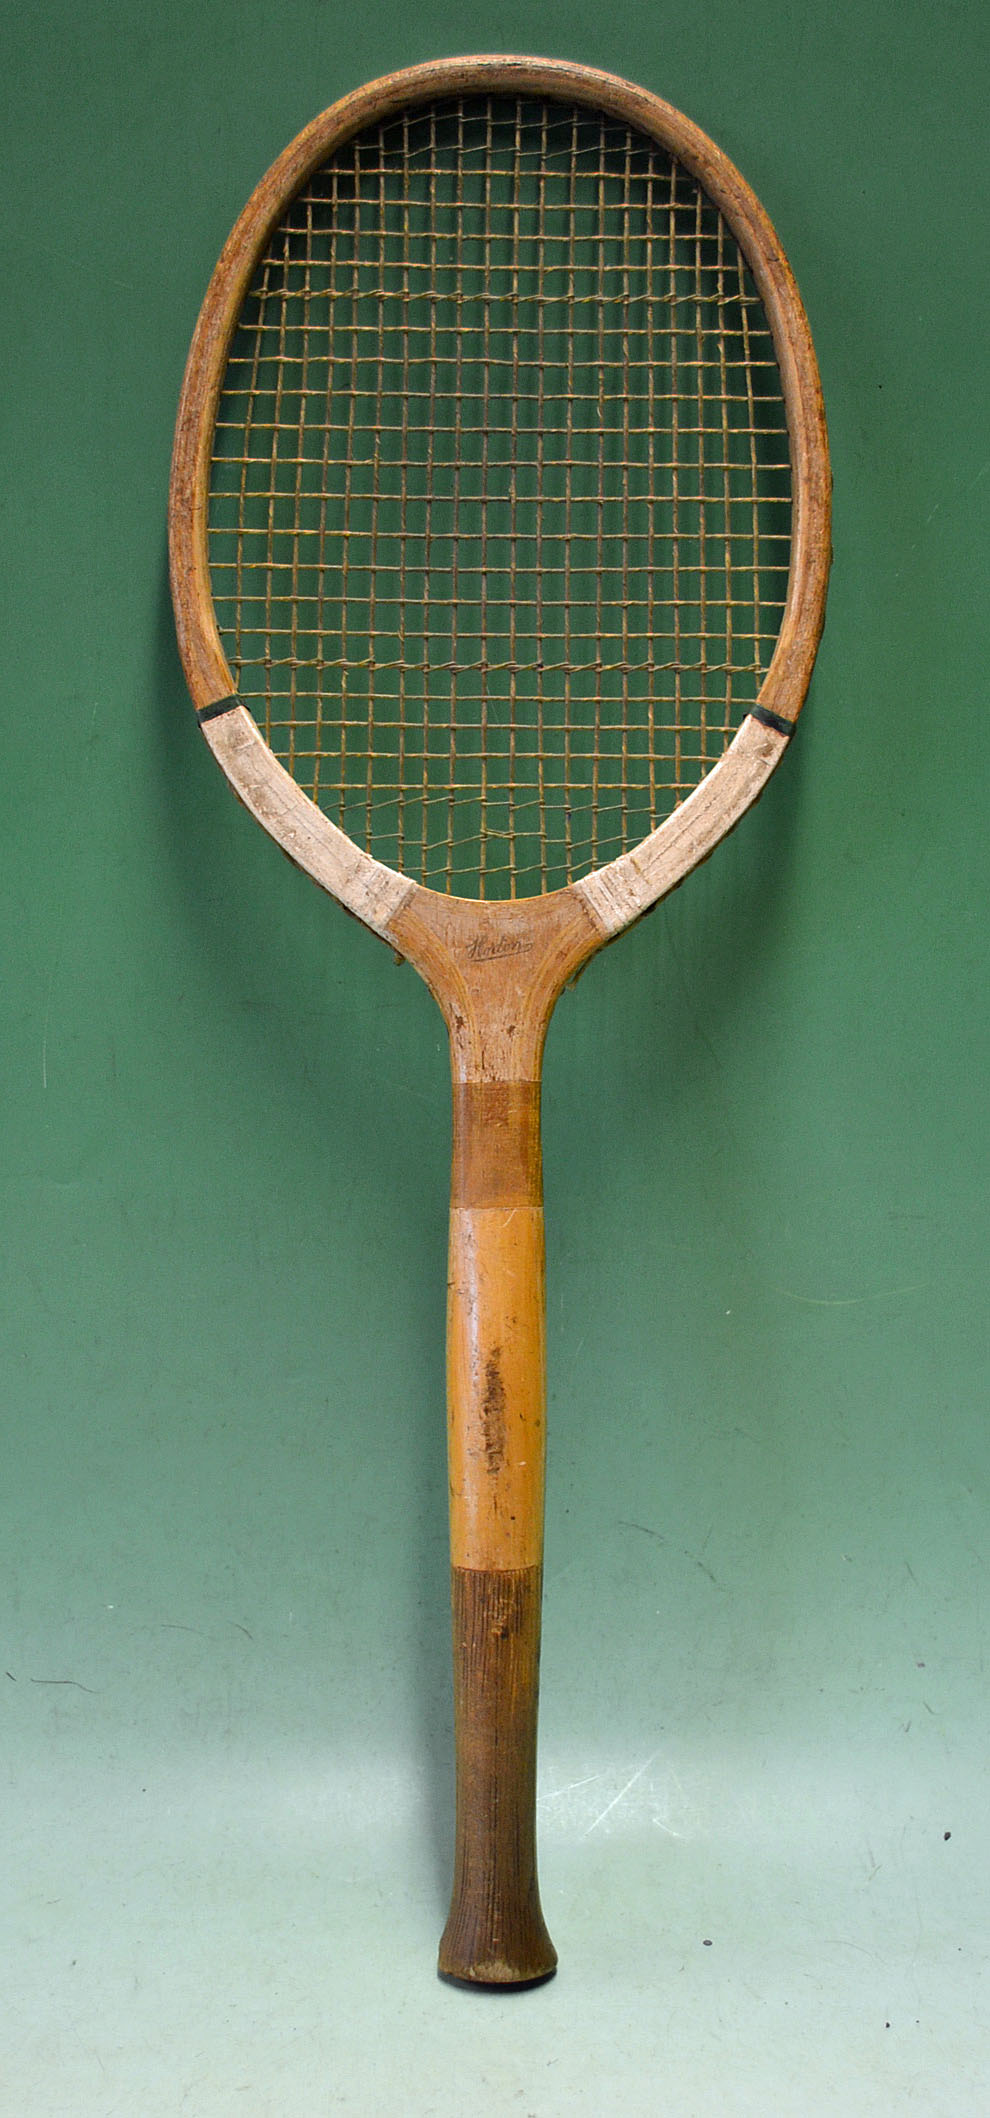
390,890,606,1985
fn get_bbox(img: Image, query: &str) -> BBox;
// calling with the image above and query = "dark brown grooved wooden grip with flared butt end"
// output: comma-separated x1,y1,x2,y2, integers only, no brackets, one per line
439,1567,558,1985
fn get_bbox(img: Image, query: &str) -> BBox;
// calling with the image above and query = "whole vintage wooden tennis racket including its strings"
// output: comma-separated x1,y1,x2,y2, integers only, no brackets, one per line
170,57,829,1985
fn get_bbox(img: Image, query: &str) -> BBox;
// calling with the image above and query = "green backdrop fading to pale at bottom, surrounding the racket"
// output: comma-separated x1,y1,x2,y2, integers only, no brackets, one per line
0,0,990,2118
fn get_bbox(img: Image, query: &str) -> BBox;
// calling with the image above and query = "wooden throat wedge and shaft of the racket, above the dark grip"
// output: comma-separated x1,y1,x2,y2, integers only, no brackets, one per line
390,890,604,1569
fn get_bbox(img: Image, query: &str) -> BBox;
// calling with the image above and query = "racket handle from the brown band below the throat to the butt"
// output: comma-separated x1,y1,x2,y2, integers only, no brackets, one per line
439,1082,558,1985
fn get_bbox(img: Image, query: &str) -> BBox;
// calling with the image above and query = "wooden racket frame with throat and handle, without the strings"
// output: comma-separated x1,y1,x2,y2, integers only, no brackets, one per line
170,55,831,1985
